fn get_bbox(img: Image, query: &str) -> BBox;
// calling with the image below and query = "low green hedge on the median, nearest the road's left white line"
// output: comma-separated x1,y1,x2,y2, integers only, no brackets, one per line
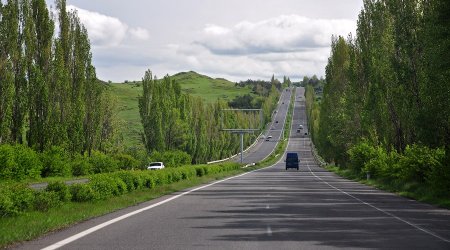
0,163,240,217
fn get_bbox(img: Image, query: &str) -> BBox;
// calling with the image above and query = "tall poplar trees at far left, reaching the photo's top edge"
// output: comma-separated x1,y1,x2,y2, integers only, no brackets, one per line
0,0,113,153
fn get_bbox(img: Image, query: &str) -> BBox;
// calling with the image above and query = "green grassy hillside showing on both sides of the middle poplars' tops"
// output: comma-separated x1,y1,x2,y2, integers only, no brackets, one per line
108,71,251,148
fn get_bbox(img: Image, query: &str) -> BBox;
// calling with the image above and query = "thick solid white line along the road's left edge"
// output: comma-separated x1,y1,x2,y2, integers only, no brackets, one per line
42,166,271,250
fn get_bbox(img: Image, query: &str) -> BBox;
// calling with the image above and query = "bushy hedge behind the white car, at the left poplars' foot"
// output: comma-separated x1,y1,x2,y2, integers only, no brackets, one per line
0,144,191,181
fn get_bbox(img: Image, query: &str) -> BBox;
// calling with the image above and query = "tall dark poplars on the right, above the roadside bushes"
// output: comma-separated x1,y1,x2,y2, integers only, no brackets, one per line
309,0,450,165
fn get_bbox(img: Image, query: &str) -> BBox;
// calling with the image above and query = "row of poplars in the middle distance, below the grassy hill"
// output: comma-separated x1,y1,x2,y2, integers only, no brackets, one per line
139,71,279,163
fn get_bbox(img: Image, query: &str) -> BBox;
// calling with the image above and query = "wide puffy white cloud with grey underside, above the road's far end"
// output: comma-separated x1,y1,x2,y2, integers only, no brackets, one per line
196,15,356,54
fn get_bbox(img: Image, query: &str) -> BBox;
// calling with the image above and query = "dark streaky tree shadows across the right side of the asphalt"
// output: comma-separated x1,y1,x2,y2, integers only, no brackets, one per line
181,167,450,249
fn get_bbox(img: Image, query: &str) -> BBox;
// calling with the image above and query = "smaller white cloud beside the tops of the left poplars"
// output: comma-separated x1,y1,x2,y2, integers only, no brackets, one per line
67,5,150,47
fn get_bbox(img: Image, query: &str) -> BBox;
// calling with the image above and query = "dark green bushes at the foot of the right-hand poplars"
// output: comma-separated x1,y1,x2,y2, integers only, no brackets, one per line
348,142,450,197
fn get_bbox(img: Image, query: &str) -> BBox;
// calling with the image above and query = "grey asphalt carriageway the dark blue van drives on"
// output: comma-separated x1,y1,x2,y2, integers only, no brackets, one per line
14,89,450,249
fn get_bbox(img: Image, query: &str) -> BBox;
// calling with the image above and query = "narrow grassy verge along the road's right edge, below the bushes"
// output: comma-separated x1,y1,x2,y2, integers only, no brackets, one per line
325,165,450,209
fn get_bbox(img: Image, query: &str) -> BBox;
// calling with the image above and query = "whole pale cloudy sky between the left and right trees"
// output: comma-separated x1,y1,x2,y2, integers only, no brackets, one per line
47,0,362,81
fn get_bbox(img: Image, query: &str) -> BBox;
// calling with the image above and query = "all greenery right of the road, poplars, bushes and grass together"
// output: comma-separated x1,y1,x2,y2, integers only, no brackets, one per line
306,0,450,207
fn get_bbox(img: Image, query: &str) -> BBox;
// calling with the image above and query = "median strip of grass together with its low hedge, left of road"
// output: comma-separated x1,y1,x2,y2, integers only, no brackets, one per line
0,163,246,247
